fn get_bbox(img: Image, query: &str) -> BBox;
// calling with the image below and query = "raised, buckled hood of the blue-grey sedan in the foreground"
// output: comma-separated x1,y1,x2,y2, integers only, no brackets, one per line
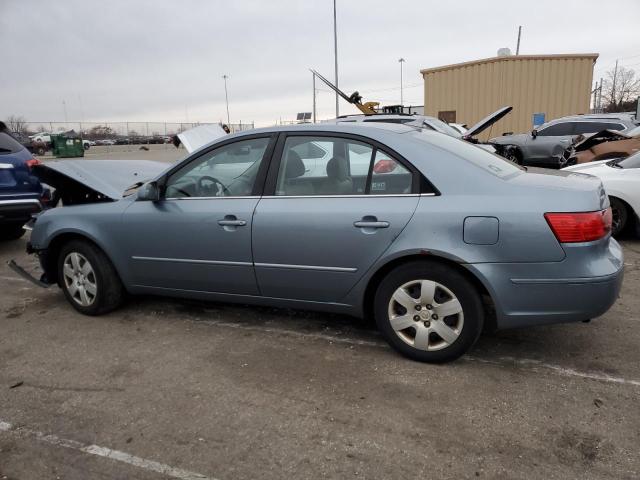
33,160,169,200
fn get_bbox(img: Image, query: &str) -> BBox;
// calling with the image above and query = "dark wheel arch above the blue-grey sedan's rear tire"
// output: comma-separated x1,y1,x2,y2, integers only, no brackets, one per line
362,253,497,331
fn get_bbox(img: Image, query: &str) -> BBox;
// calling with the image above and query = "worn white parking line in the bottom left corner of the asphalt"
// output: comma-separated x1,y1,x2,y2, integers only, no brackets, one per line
0,421,216,480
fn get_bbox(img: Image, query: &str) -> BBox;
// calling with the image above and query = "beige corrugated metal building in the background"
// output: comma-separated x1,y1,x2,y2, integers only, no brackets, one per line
420,53,598,139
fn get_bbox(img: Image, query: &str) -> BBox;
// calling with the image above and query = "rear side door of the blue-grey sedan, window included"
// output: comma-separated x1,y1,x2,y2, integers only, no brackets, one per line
253,133,419,302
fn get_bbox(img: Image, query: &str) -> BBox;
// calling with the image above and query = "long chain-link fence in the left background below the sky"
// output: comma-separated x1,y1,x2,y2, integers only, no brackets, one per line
15,122,254,145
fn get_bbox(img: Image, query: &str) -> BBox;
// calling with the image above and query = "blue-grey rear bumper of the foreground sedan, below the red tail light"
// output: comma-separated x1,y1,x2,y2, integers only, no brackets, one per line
467,239,624,329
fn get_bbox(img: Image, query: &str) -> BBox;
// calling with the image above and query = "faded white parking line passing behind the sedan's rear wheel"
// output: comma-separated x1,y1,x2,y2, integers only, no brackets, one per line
189,319,640,387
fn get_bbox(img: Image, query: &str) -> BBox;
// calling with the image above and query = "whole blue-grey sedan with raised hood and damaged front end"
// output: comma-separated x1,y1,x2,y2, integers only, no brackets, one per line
14,123,623,362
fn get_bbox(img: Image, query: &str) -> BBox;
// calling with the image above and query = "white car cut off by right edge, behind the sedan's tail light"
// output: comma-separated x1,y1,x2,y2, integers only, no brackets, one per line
563,152,640,235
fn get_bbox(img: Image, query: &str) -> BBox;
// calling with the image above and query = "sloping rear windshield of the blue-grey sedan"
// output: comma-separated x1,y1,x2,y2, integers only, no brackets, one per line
407,130,525,178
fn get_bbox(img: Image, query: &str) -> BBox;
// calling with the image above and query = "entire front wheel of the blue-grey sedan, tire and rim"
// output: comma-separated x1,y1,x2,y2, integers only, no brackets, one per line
58,240,124,315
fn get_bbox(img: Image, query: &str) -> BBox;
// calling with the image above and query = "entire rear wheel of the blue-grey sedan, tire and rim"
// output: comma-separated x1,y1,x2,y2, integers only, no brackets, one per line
374,261,484,363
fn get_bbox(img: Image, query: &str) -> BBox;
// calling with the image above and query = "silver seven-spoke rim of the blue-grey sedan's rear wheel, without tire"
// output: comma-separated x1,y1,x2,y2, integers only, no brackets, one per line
388,280,464,351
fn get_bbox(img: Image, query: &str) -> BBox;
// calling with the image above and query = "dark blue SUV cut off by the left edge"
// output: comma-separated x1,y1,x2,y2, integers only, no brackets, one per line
0,122,48,240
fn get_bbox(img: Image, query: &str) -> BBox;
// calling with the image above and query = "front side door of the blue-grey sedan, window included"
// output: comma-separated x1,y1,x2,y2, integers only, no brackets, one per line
123,136,275,295
